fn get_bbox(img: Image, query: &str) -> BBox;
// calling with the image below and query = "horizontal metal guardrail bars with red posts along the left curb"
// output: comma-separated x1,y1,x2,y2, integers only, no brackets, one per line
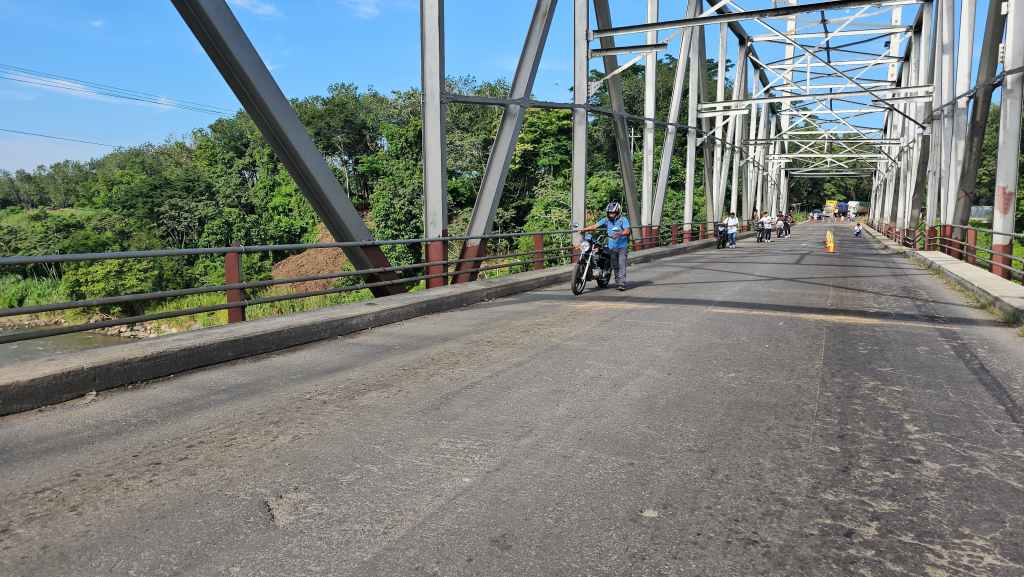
0,221,750,344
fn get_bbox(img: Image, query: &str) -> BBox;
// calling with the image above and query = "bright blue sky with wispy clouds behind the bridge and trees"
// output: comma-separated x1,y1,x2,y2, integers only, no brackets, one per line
0,0,985,170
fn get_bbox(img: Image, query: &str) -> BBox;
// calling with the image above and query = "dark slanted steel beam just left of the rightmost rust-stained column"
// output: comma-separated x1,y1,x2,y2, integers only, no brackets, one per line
953,1,1007,226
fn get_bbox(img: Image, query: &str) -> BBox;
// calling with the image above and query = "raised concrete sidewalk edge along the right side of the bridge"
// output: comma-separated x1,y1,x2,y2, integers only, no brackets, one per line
864,226,1024,325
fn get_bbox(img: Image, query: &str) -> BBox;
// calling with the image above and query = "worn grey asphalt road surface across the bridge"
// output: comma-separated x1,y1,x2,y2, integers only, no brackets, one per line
0,224,1024,577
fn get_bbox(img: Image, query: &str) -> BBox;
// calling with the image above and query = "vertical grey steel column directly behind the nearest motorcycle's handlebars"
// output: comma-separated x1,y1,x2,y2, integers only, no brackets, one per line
570,0,589,244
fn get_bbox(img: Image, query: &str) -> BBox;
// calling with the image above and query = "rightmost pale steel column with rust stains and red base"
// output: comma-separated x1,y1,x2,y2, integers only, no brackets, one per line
992,0,1024,278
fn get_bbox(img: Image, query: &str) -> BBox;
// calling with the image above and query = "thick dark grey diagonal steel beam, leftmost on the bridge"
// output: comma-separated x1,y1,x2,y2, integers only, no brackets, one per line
171,0,403,296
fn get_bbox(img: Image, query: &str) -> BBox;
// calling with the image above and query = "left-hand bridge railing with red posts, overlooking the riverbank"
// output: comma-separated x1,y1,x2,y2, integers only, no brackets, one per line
0,222,749,344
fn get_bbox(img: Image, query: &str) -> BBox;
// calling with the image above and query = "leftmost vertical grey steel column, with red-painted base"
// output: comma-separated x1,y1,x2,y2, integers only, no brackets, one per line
420,0,448,288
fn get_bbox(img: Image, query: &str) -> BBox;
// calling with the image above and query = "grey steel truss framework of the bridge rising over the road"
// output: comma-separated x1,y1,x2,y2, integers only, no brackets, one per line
172,0,1024,286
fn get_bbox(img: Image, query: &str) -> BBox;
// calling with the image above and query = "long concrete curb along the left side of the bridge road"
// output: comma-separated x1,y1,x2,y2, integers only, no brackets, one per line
0,233,752,416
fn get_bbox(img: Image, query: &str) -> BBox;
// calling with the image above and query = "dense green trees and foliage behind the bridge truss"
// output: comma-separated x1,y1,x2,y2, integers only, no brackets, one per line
0,56,1019,312
